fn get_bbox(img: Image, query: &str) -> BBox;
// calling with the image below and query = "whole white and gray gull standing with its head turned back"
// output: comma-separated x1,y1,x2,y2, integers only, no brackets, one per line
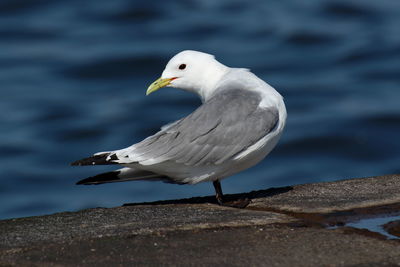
71,50,287,207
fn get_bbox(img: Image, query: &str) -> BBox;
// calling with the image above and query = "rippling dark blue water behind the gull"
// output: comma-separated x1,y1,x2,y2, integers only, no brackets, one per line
0,0,400,221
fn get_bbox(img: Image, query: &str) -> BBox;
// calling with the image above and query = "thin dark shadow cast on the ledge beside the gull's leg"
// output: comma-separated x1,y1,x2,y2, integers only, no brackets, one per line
123,186,293,206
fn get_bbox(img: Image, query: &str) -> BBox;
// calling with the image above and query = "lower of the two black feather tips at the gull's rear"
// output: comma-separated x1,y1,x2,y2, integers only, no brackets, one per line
76,168,167,185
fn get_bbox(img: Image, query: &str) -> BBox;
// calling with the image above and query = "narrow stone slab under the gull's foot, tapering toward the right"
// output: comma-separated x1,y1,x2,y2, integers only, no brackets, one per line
0,204,294,248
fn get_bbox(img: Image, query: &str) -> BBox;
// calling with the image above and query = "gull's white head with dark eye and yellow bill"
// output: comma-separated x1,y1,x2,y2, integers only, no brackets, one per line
146,50,229,101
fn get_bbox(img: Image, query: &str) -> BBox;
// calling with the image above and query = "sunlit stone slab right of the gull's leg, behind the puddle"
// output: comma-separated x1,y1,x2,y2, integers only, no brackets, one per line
250,175,400,213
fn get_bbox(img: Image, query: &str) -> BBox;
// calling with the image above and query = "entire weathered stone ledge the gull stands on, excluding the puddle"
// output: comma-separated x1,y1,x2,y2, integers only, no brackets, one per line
0,175,400,266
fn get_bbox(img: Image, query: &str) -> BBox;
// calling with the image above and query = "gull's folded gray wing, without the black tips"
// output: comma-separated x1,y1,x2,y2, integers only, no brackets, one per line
117,90,279,166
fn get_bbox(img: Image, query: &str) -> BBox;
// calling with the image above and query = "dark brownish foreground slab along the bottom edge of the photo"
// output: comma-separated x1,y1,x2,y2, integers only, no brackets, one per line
0,225,400,266
